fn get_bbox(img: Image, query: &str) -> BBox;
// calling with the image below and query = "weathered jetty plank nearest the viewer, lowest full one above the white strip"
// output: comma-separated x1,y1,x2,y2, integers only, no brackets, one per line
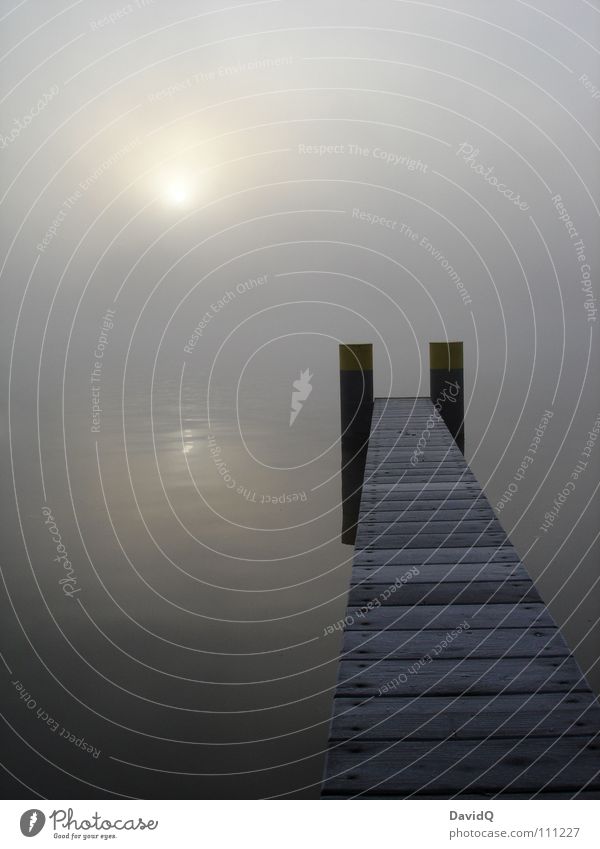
324,736,600,795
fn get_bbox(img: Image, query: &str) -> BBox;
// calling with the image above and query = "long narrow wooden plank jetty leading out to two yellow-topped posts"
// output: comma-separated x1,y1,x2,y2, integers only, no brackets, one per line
322,398,600,799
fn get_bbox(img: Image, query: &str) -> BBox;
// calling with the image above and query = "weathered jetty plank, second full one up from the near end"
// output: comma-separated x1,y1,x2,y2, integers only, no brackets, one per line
331,692,600,740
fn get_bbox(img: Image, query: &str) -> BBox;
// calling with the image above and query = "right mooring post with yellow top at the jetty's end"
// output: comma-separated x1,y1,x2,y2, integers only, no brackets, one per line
429,342,465,454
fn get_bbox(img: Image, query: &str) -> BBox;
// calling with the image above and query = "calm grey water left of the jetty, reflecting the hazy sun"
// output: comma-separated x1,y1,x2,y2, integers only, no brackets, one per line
4,358,352,798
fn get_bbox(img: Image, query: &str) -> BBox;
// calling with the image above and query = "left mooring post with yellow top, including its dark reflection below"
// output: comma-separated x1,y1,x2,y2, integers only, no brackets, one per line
340,344,373,545
